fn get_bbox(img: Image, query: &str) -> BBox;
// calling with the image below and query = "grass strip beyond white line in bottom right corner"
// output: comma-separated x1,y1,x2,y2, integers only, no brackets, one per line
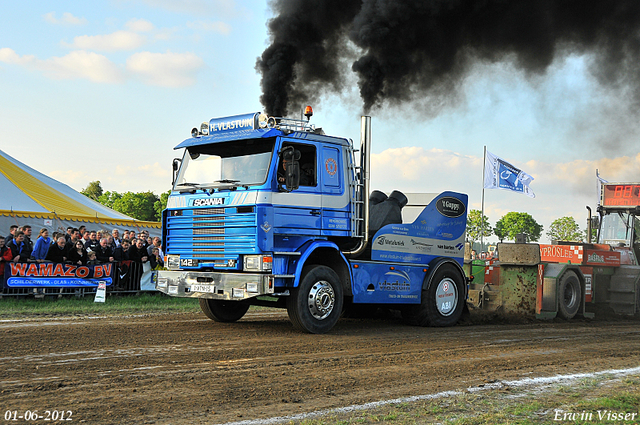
289,376,640,425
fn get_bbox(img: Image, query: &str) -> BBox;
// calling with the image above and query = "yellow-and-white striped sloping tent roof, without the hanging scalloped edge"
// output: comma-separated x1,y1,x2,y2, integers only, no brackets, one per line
0,150,160,227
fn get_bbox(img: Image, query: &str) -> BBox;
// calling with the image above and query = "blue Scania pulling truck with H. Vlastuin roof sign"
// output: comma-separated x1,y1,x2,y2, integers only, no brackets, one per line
155,111,468,333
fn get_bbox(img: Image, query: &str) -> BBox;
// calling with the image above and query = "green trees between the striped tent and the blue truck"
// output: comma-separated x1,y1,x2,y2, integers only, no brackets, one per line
80,180,171,221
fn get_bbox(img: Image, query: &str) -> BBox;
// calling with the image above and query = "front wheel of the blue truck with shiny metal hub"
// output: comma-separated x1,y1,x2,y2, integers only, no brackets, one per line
287,266,344,334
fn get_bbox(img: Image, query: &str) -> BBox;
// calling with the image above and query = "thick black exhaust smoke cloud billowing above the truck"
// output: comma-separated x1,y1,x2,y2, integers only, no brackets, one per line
256,0,640,116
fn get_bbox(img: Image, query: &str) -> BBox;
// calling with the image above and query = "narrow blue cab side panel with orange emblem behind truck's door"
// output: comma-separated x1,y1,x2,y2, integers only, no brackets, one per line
318,146,350,236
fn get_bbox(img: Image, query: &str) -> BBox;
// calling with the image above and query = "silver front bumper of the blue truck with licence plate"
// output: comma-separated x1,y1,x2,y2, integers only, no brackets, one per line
156,270,274,301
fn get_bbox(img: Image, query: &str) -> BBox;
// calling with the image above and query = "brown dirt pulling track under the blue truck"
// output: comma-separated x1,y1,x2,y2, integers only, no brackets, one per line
0,310,640,424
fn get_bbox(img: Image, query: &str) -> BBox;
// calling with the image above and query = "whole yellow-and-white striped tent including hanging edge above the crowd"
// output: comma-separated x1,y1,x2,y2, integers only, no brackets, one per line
0,150,160,235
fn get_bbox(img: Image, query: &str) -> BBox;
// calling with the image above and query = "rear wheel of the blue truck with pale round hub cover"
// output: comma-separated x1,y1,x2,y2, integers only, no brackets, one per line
402,264,465,326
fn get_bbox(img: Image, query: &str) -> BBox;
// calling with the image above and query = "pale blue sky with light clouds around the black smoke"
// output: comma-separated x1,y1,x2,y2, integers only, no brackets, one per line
0,0,640,242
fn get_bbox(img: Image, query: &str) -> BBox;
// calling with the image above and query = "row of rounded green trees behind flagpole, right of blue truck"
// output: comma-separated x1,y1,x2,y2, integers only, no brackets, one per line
467,210,586,242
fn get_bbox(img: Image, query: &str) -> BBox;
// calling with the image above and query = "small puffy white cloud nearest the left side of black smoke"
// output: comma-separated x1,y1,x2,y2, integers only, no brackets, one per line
127,52,204,87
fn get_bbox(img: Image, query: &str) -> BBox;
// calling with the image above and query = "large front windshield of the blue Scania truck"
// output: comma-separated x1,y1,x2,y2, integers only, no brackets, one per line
173,139,275,190
